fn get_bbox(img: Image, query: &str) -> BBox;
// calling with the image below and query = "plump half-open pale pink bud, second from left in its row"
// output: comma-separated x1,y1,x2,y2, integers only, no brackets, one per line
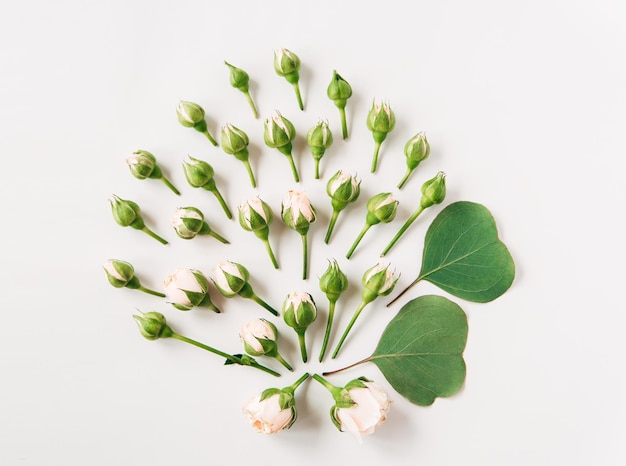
163,269,220,313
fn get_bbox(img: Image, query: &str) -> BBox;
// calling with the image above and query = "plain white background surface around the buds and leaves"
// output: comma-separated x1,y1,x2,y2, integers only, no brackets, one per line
0,0,626,466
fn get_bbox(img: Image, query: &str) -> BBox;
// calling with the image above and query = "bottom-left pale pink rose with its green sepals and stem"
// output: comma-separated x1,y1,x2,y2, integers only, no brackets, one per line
242,373,309,434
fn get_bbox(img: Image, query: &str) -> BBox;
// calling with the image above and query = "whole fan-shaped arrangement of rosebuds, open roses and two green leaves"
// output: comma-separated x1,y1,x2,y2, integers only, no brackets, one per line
104,49,515,440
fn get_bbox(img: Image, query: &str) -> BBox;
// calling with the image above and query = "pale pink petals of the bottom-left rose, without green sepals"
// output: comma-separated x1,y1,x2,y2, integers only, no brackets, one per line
243,390,296,434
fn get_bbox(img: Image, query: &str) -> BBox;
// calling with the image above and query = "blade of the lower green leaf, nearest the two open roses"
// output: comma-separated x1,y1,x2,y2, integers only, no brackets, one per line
363,295,467,406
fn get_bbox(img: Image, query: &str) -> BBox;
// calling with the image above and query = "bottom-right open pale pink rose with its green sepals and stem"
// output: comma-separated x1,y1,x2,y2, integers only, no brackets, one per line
313,374,391,443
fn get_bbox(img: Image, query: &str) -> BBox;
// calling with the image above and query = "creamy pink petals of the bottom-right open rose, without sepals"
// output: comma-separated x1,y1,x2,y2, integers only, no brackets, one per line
334,381,391,442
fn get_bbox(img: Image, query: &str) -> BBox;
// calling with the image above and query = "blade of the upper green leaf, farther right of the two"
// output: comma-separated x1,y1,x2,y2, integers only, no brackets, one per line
414,201,515,303
